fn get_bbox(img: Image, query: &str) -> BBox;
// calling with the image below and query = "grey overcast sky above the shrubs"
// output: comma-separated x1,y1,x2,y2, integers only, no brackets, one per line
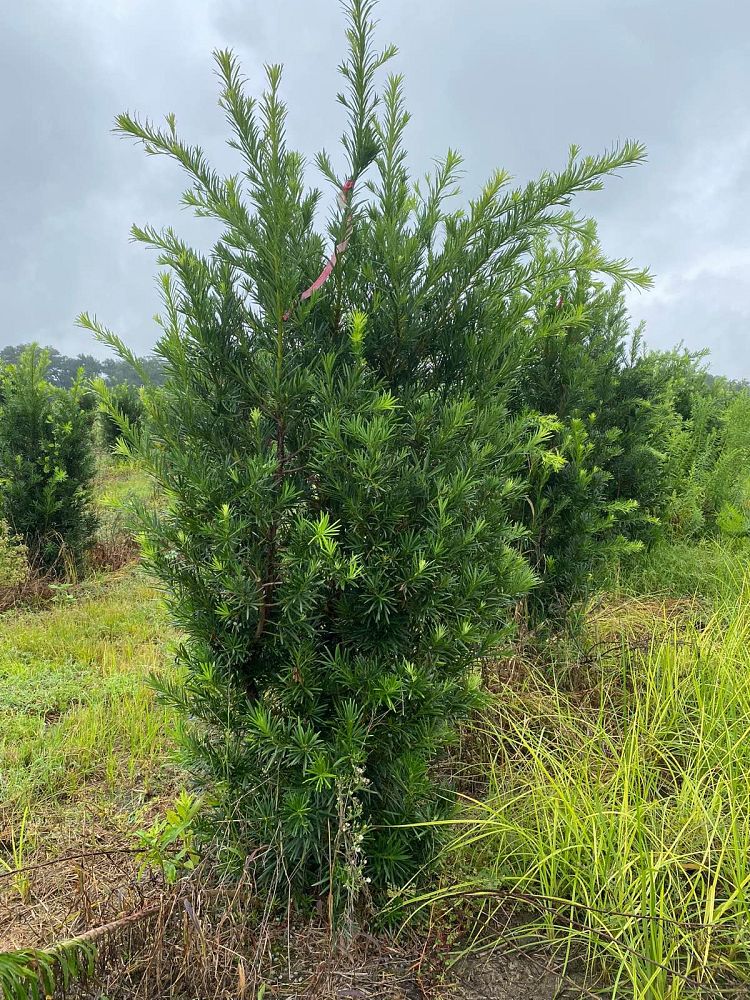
0,0,750,377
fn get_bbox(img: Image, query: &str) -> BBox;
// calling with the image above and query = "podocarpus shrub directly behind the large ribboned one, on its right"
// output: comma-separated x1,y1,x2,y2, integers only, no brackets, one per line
514,234,655,625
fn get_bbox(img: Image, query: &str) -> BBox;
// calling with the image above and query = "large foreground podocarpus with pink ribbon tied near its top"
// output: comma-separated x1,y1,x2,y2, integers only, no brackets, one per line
82,0,642,898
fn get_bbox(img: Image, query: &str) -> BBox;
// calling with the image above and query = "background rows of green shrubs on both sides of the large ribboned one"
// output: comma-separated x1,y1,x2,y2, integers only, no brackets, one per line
0,274,750,604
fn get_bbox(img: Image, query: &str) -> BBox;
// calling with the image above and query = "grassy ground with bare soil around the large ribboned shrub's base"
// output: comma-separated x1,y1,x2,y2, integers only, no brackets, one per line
0,458,750,1000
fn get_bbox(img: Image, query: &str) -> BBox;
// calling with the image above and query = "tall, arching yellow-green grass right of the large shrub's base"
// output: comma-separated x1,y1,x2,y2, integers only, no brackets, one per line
430,554,750,1000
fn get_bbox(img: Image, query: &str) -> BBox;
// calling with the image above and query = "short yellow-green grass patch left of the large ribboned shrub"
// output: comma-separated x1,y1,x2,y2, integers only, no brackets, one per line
0,566,175,834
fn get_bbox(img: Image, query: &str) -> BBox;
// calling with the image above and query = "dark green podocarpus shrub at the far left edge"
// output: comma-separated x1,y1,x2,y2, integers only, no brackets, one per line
0,344,95,572
